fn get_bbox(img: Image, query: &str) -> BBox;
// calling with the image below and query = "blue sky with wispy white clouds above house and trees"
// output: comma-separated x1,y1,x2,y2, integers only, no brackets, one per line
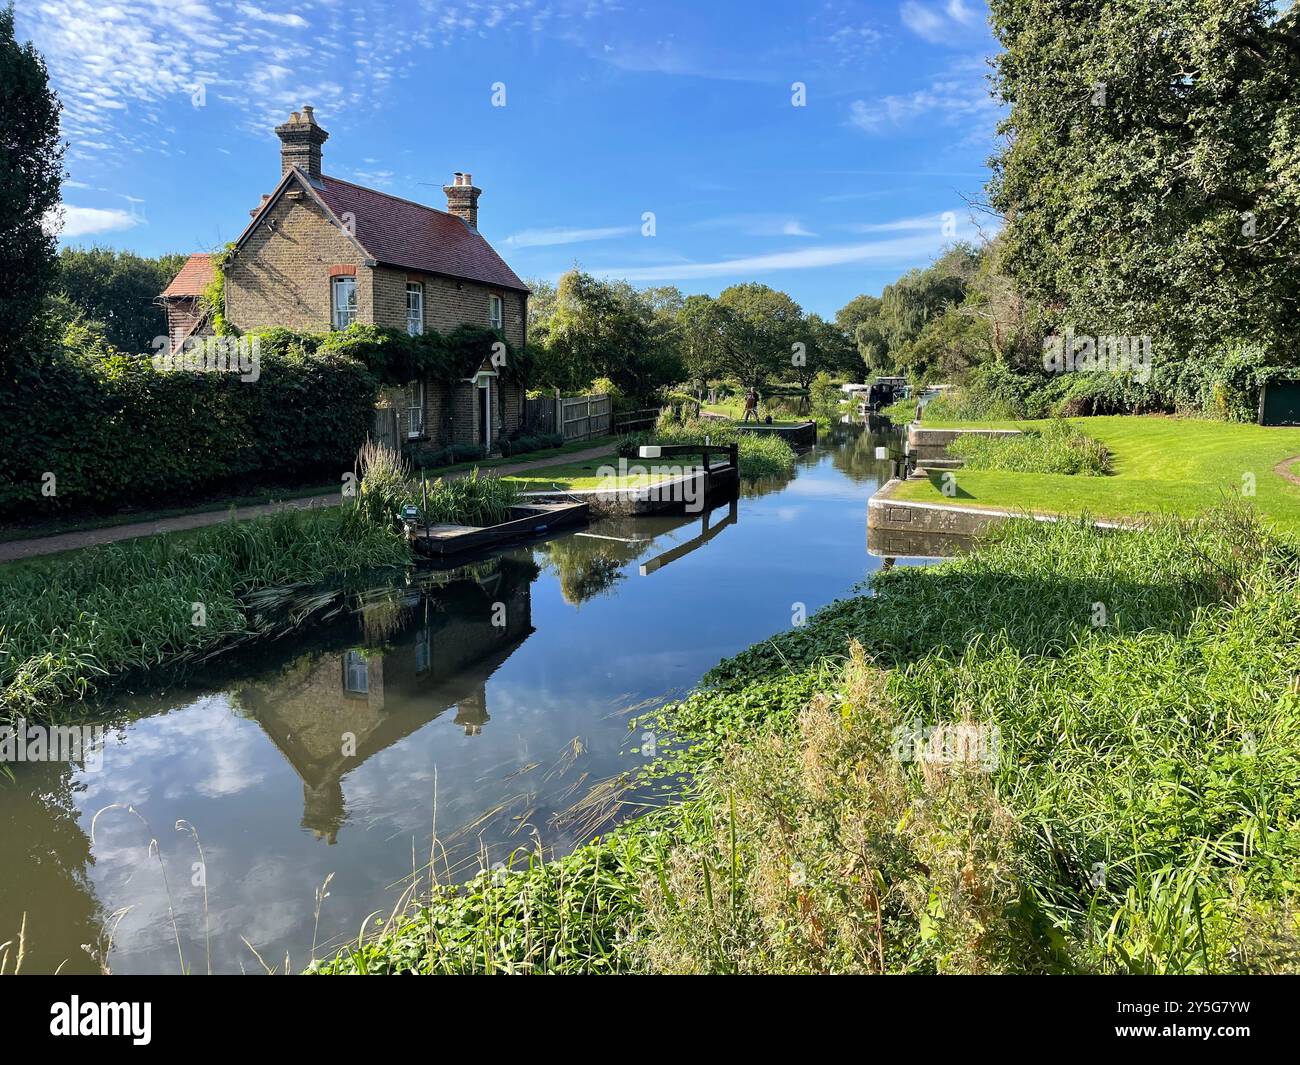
17,0,1000,315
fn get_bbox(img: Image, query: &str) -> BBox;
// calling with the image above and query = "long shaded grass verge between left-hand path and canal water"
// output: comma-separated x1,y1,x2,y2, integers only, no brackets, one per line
0,508,410,722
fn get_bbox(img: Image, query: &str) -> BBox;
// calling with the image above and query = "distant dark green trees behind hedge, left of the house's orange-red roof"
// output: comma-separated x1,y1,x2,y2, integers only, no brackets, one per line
59,247,185,352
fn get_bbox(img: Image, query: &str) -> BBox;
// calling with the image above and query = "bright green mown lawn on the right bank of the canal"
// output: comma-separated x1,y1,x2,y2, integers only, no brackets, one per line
896,416,1300,532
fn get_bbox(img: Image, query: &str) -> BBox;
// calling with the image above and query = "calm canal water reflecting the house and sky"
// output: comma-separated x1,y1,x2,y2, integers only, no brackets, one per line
0,425,925,973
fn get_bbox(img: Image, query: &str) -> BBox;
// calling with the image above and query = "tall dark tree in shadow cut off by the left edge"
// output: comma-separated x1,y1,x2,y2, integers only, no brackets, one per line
0,5,64,366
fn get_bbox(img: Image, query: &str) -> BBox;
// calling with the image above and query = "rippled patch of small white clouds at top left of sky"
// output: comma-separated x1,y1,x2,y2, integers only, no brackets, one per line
18,0,624,159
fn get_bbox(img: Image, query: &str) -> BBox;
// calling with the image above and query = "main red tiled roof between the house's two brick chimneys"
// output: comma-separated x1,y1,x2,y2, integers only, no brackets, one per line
315,176,528,291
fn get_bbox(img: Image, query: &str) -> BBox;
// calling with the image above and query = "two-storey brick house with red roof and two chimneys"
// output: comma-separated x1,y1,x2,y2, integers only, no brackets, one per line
161,105,529,450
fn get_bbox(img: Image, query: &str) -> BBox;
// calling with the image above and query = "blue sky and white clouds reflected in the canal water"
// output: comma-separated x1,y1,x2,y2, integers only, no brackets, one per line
12,434,904,973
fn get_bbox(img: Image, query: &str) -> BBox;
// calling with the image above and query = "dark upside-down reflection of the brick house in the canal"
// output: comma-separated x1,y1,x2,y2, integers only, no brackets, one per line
239,560,536,843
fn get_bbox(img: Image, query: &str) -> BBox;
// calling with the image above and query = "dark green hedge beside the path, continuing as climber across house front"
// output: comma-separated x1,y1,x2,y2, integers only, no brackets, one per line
0,325,525,520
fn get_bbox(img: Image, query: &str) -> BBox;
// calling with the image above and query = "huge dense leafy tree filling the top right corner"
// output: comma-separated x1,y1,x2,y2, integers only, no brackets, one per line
989,0,1300,360
